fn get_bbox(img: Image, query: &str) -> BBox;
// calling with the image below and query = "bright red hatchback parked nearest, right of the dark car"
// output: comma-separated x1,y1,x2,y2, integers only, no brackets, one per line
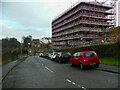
70,51,100,69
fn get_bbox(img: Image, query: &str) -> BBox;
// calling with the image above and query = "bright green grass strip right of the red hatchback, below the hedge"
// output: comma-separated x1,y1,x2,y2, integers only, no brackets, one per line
99,58,120,66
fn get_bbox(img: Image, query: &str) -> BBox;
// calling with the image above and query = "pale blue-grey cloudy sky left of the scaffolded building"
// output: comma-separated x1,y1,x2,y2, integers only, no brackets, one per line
0,0,119,41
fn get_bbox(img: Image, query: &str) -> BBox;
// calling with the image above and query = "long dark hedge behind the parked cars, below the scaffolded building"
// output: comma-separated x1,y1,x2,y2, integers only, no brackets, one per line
56,42,120,59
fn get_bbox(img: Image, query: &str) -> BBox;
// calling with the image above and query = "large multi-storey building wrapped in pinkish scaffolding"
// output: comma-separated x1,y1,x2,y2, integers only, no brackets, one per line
52,2,114,49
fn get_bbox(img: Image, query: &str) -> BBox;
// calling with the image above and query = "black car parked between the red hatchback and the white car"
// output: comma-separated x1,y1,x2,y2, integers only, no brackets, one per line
55,52,71,63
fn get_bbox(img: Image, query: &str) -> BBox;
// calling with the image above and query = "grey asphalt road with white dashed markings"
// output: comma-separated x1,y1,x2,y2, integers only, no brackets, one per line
2,56,118,89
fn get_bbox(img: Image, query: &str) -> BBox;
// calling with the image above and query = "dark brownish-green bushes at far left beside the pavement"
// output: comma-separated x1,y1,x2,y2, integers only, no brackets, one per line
2,38,20,63
